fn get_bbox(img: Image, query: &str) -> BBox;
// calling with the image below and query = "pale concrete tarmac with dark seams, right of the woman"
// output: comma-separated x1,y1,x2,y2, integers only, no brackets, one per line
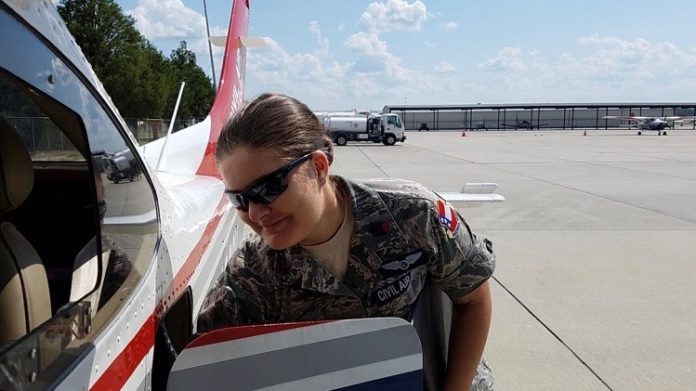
333,130,696,390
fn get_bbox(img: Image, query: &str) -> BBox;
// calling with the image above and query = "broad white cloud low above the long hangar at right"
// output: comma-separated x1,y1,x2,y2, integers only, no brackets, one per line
479,34,696,102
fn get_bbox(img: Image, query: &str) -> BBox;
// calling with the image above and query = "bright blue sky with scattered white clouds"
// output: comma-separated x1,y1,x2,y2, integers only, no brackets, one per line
118,0,696,110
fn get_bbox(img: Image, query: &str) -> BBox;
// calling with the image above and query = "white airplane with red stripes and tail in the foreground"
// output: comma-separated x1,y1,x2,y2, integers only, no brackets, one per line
0,0,502,390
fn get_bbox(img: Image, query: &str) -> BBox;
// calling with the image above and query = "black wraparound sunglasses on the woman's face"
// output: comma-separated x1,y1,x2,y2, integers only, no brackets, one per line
225,152,314,212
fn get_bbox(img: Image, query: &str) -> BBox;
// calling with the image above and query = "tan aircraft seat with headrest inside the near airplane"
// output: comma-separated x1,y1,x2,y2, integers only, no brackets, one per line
0,117,51,346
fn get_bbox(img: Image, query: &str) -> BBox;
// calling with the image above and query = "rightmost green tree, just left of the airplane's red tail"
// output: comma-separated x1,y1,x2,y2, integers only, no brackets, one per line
169,41,215,119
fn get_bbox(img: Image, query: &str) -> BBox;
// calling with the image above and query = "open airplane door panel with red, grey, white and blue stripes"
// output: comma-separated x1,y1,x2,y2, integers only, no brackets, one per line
167,318,423,390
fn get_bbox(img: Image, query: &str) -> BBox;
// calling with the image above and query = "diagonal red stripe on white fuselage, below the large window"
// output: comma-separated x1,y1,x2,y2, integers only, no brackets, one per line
90,196,228,391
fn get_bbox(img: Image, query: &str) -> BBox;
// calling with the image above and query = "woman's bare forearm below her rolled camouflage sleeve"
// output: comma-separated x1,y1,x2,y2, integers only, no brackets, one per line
444,280,493,391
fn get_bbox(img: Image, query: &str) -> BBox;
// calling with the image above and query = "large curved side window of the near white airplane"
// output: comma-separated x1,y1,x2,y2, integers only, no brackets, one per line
0,9,159,389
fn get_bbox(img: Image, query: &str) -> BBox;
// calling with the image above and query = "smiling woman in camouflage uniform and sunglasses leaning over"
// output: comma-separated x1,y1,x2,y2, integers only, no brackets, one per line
198,94,495,389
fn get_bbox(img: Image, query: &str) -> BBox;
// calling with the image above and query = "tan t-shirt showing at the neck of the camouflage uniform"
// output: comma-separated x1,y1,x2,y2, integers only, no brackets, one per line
302,203,353,281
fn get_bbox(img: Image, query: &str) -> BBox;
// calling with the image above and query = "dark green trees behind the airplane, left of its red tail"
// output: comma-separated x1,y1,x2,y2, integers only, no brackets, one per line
57,0,215,120
